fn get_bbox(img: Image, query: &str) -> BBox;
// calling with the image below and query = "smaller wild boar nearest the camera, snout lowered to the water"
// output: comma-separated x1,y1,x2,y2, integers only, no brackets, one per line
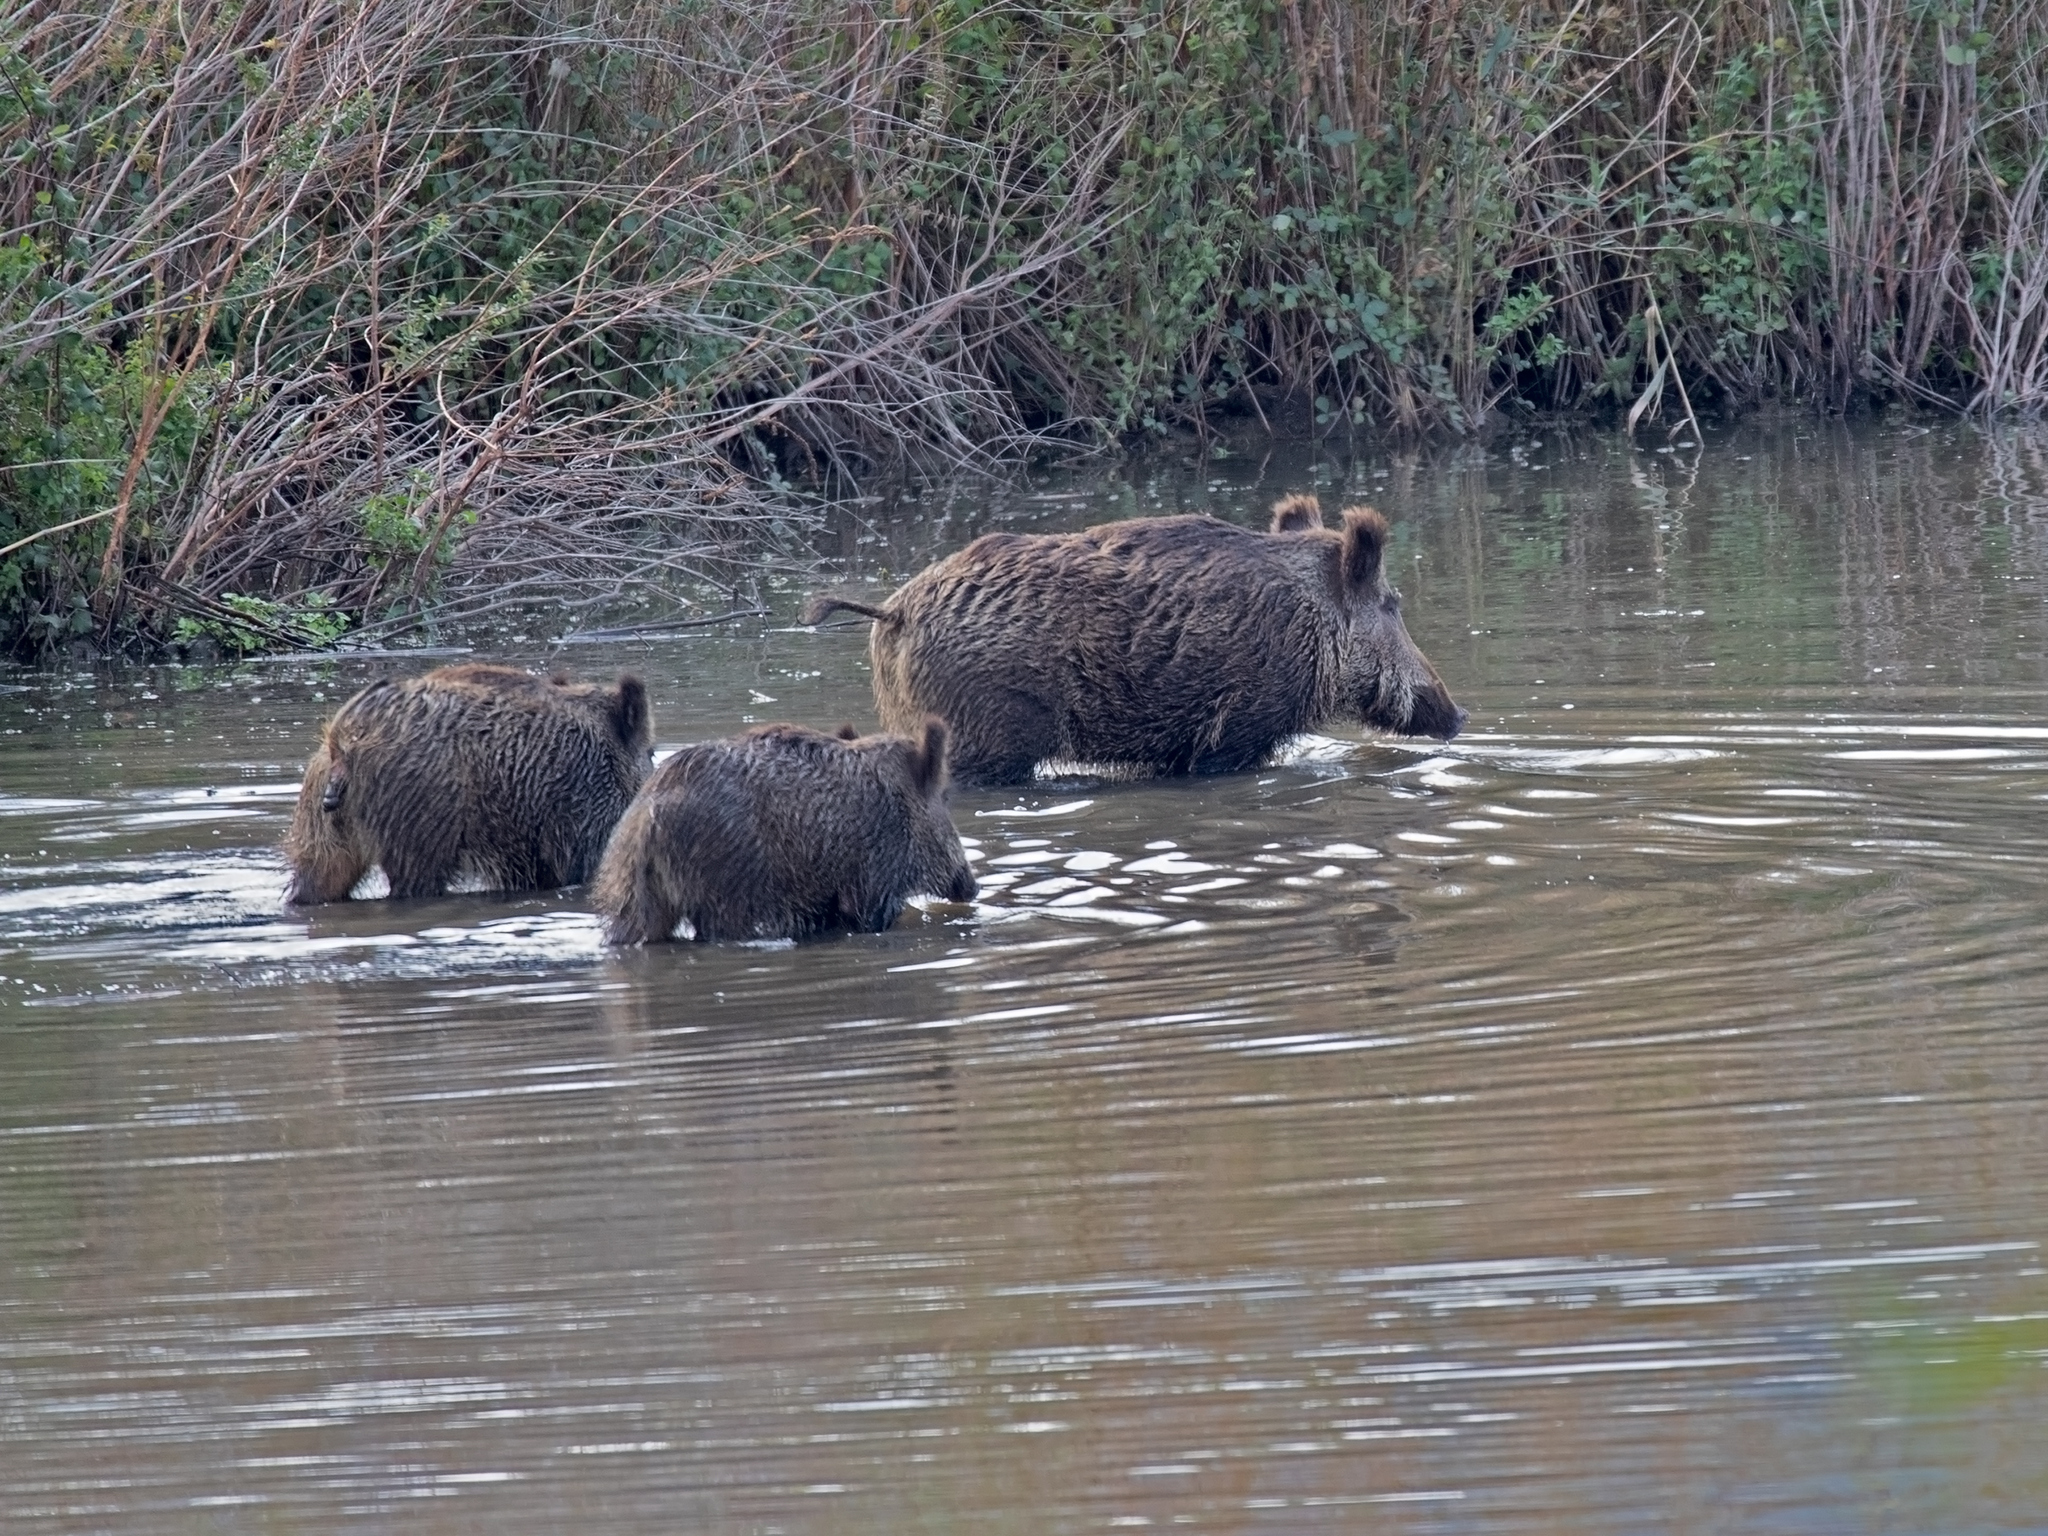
592,719,975,944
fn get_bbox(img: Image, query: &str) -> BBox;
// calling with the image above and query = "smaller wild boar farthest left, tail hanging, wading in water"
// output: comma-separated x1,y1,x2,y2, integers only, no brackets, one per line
285,664,653,903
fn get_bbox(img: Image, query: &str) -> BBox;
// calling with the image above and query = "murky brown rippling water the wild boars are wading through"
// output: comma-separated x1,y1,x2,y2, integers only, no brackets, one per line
0,426,2048,1536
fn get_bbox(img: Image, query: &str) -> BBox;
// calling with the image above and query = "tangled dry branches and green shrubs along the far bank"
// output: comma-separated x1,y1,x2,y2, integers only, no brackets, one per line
0,0,2048,657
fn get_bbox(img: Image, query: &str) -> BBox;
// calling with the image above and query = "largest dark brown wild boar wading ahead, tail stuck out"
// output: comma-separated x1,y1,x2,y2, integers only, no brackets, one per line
805,496,1466,784
